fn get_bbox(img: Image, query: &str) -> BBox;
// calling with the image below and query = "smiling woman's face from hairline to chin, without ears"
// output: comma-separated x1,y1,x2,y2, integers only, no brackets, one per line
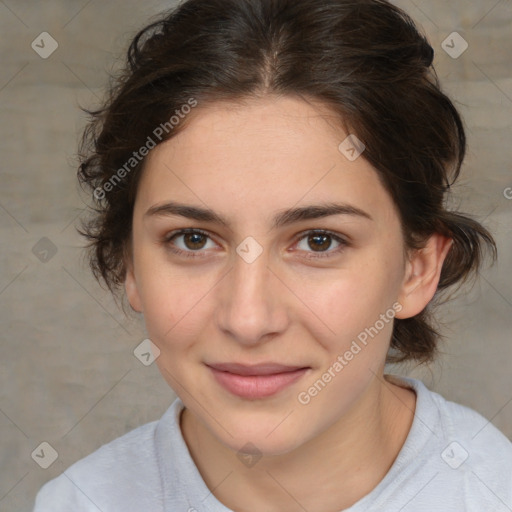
126,97,414,454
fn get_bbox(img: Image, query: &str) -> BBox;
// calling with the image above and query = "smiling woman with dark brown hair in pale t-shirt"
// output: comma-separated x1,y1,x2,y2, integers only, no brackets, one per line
35,0,512,512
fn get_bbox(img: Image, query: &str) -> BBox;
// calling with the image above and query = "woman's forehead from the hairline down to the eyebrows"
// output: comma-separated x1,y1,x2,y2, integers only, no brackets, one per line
137,97,393,230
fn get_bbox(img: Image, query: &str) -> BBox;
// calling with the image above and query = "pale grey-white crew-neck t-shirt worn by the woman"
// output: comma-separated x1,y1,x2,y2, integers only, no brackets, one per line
33,377,512,512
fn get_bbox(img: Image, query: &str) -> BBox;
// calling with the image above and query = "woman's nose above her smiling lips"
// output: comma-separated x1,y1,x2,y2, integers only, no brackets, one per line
216,244,290,346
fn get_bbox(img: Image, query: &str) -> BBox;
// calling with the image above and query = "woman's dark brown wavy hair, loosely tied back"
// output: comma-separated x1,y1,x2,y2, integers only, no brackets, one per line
78,0,496,362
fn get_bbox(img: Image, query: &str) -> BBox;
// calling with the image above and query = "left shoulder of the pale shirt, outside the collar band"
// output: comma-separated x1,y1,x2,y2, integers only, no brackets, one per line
33,404,178,512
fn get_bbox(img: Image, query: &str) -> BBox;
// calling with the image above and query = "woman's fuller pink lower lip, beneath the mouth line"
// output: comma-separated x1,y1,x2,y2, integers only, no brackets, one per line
210,367,308,399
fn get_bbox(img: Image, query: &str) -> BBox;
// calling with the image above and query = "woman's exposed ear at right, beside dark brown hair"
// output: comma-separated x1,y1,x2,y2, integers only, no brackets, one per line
396,233,453,318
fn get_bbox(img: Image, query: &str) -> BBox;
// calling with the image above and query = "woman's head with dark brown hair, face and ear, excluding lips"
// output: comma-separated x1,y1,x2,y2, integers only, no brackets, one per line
79,0,495,453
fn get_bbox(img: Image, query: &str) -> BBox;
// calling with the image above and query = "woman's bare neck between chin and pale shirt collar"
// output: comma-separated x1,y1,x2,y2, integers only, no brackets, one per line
181,376,416,512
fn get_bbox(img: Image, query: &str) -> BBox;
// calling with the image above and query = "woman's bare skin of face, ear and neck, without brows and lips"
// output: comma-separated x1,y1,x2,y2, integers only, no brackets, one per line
125,96,450,512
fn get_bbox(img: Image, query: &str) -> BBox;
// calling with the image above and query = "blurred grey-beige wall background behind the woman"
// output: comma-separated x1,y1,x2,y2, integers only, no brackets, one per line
0,0,512,512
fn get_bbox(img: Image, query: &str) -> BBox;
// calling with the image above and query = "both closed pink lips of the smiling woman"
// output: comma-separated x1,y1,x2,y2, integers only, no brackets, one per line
207,363,310,400
